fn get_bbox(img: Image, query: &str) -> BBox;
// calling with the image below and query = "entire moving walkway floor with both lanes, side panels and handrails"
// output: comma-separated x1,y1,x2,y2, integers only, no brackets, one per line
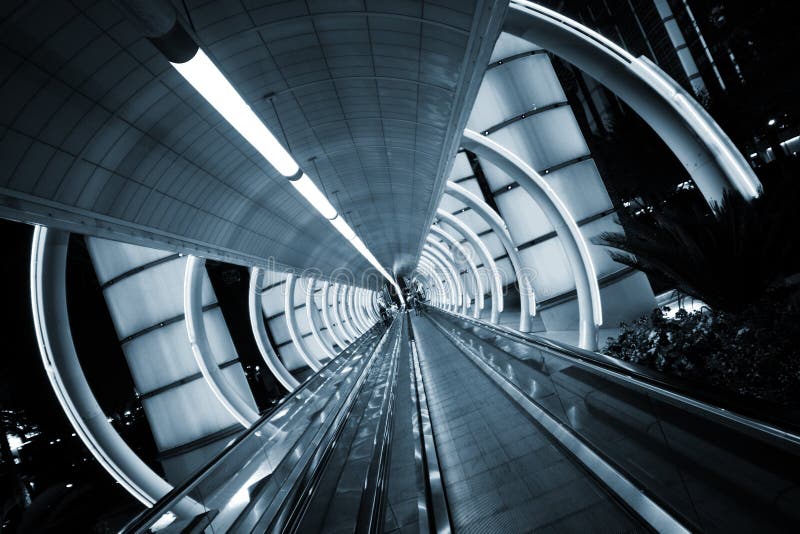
125,309,800,534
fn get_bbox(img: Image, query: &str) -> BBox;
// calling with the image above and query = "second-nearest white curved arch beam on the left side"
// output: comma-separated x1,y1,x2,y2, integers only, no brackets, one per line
183,256,259,428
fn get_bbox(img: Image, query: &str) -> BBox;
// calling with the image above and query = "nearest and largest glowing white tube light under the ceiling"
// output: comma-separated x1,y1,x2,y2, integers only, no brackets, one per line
172,48,300,176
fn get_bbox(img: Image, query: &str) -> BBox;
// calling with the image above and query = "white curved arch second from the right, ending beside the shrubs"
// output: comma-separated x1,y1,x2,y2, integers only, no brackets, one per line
461,130,603,350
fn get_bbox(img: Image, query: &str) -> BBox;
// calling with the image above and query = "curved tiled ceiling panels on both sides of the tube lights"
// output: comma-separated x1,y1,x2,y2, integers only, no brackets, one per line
0,0,507,286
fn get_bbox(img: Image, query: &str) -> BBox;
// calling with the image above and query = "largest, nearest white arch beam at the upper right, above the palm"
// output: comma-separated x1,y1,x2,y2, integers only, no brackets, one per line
504,0,761,205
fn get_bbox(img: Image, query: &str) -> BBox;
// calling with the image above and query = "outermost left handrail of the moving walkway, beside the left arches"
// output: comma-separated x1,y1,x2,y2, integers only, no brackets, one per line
120,324,383,534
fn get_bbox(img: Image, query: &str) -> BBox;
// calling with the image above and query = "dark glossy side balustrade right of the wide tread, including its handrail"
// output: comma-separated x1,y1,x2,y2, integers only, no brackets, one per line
432,311,800,532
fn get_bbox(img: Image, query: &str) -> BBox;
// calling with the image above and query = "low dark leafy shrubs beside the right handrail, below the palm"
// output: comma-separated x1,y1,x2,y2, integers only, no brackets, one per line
605,293,800,405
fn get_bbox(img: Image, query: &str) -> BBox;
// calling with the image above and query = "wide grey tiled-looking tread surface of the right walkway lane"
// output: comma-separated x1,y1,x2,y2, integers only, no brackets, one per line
413,316,639,533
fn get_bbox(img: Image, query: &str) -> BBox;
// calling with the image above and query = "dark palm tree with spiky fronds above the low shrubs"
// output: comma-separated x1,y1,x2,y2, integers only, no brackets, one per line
594,182,800,312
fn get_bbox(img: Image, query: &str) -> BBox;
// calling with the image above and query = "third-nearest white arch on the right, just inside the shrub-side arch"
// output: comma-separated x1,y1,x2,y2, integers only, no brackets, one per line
445,181,536,332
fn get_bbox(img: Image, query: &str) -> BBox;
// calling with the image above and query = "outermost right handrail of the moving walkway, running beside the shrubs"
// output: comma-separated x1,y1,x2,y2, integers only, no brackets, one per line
428,307,800,454
